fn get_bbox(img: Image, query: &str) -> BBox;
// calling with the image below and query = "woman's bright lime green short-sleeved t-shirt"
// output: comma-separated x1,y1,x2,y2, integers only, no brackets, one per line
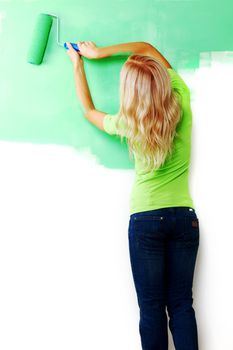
104,68,194,214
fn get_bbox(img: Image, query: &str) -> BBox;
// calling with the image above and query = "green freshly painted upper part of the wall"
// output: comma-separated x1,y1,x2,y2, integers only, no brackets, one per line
0,0,233,168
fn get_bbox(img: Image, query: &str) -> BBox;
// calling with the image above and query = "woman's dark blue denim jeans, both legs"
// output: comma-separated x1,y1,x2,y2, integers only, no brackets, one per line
128,207,199,350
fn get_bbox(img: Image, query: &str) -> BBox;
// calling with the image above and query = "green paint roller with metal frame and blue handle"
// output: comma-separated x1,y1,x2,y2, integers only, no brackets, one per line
27,13,79,65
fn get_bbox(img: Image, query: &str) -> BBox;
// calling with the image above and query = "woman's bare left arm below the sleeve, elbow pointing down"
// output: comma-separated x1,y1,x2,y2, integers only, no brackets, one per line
67,42,107,131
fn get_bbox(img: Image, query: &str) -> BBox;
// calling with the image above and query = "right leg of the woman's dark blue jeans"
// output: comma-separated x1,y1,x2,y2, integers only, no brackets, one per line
166,214,199,350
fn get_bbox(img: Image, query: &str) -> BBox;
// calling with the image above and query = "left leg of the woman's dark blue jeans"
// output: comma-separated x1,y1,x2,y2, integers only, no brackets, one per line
128,220,168,350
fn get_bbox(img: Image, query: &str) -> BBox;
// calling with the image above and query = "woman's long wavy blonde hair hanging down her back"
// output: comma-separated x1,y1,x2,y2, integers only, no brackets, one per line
116,54,182,170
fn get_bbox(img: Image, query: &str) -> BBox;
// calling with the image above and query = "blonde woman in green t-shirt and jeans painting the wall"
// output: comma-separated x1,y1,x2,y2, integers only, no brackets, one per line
67,42,199,350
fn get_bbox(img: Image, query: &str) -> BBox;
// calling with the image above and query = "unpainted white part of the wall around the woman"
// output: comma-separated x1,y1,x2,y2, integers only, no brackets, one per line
0,55,233,350
